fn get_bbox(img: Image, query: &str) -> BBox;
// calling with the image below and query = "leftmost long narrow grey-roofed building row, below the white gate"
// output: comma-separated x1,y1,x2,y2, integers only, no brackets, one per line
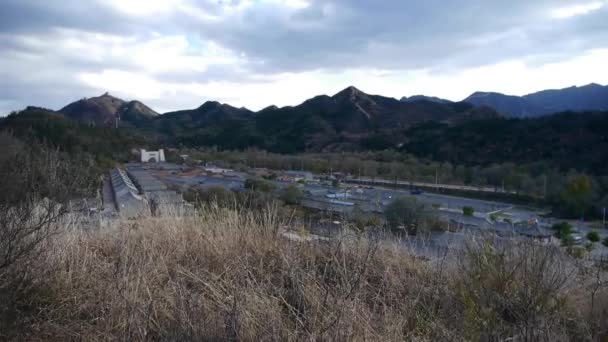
110,168,150,218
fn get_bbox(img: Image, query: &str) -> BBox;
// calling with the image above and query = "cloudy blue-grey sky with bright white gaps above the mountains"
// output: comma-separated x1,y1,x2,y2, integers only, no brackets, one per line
0,0,608,115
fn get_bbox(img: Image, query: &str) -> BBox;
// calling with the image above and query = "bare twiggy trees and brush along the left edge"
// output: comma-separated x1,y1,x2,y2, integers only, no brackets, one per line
0,133,94,308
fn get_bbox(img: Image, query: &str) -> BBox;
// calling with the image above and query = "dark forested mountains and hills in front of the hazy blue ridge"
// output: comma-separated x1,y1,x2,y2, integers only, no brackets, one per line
0,86,608,173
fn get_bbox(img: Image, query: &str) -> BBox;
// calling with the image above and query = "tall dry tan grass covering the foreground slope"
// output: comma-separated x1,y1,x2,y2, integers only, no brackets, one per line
0,204,608,341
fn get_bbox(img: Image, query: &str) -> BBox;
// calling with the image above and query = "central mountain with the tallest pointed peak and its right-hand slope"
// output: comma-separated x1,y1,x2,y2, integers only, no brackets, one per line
227,87,497,152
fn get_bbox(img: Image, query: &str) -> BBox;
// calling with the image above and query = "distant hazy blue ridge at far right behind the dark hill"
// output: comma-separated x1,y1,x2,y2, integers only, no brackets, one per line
464,84,608,117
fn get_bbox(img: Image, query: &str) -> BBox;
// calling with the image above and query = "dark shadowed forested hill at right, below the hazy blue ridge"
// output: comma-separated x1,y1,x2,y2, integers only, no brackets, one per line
402,112,608,174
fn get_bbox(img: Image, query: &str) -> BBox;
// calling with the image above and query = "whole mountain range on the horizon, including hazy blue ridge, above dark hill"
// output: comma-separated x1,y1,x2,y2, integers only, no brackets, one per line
2,84,608,153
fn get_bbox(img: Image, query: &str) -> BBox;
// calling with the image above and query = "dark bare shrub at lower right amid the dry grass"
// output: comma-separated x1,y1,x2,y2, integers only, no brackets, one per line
457,241,580,341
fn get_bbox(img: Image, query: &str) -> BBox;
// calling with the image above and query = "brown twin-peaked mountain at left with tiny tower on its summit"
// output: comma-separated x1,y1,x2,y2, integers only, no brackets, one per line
59,93,158,127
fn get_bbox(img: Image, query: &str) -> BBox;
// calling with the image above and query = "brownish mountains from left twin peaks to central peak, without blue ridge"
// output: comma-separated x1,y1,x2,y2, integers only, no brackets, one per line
47,87,498,152
